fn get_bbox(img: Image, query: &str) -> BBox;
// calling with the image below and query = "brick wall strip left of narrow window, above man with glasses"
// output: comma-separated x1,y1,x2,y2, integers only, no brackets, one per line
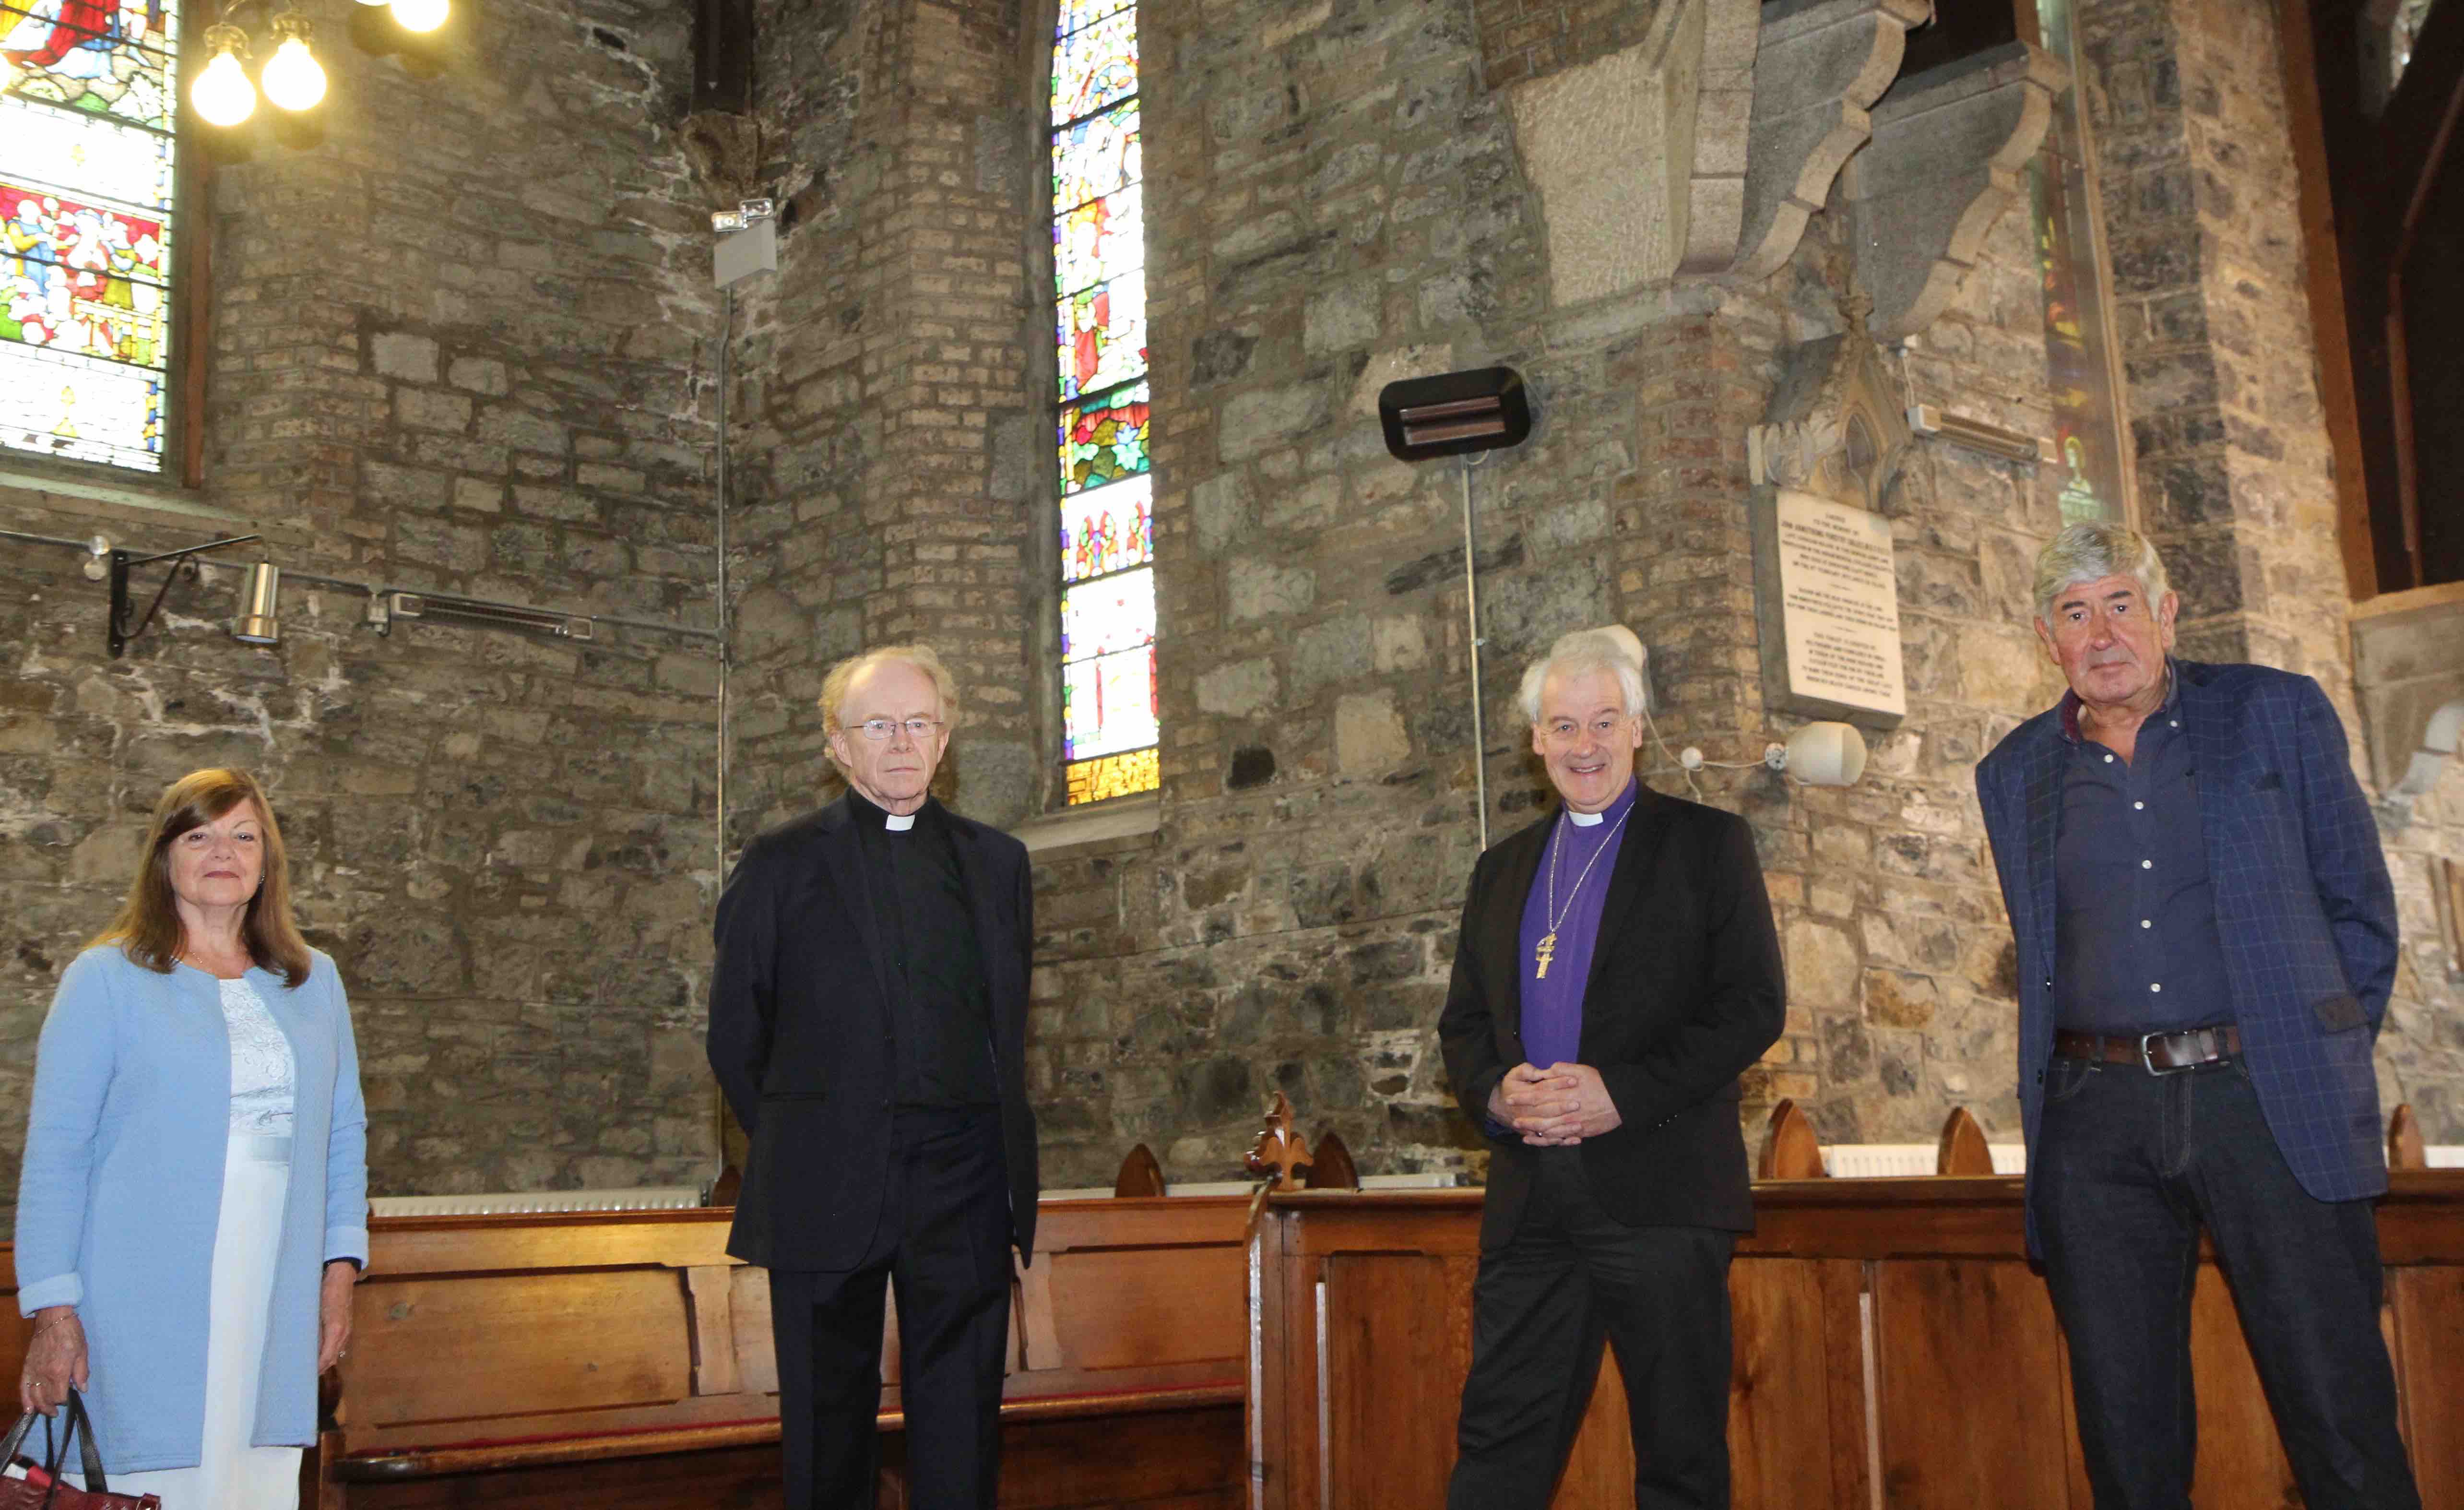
732,0,1054,843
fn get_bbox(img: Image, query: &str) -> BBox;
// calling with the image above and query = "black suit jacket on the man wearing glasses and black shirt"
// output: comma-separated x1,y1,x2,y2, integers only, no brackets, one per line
710,798,1037,1271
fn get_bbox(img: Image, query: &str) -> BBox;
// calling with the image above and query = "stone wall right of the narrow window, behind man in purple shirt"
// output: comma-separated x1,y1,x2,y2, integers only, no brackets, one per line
1000,5,2099,1185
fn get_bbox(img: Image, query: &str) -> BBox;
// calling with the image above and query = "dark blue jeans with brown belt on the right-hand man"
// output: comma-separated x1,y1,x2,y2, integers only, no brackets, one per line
2028,1057,2422,1510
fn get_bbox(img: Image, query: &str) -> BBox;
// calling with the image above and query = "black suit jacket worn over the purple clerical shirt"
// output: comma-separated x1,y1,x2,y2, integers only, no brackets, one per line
1439,788,1787,1249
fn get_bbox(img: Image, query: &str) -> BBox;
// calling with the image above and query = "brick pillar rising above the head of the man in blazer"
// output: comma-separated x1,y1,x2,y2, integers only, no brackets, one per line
2080,0,2351,679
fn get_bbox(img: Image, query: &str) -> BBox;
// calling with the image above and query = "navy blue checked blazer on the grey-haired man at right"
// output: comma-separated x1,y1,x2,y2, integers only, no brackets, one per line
1976,660,2395,1247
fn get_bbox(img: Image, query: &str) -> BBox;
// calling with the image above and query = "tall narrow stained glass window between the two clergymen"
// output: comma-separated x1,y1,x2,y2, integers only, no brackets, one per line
1044,0,1161,806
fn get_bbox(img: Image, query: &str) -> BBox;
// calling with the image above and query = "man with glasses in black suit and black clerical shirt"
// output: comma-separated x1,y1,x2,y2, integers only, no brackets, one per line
710,645,1037,1510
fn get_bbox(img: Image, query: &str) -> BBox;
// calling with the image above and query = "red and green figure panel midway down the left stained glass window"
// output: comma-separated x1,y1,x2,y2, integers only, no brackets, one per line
0,182,170,367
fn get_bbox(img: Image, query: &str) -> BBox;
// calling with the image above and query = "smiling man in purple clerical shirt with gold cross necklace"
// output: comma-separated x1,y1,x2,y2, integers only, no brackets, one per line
1439,630,1787,1510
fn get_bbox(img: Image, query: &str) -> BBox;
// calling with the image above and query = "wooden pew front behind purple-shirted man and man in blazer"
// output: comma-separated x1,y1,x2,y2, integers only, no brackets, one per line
1252,1170,2464,1510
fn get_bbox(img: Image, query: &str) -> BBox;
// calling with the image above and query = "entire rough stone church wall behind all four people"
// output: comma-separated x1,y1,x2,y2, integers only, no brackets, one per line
0,0,2464,1212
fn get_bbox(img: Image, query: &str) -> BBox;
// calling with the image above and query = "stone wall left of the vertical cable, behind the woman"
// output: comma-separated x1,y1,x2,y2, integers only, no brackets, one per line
0,0,717,1192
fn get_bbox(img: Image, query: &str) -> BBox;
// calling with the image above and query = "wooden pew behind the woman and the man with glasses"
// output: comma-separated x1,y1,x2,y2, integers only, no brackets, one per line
0,1195,1249,1510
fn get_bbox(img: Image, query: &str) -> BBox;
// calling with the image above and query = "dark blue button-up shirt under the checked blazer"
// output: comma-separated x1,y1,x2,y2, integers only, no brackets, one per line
2052,663,2232,1034
